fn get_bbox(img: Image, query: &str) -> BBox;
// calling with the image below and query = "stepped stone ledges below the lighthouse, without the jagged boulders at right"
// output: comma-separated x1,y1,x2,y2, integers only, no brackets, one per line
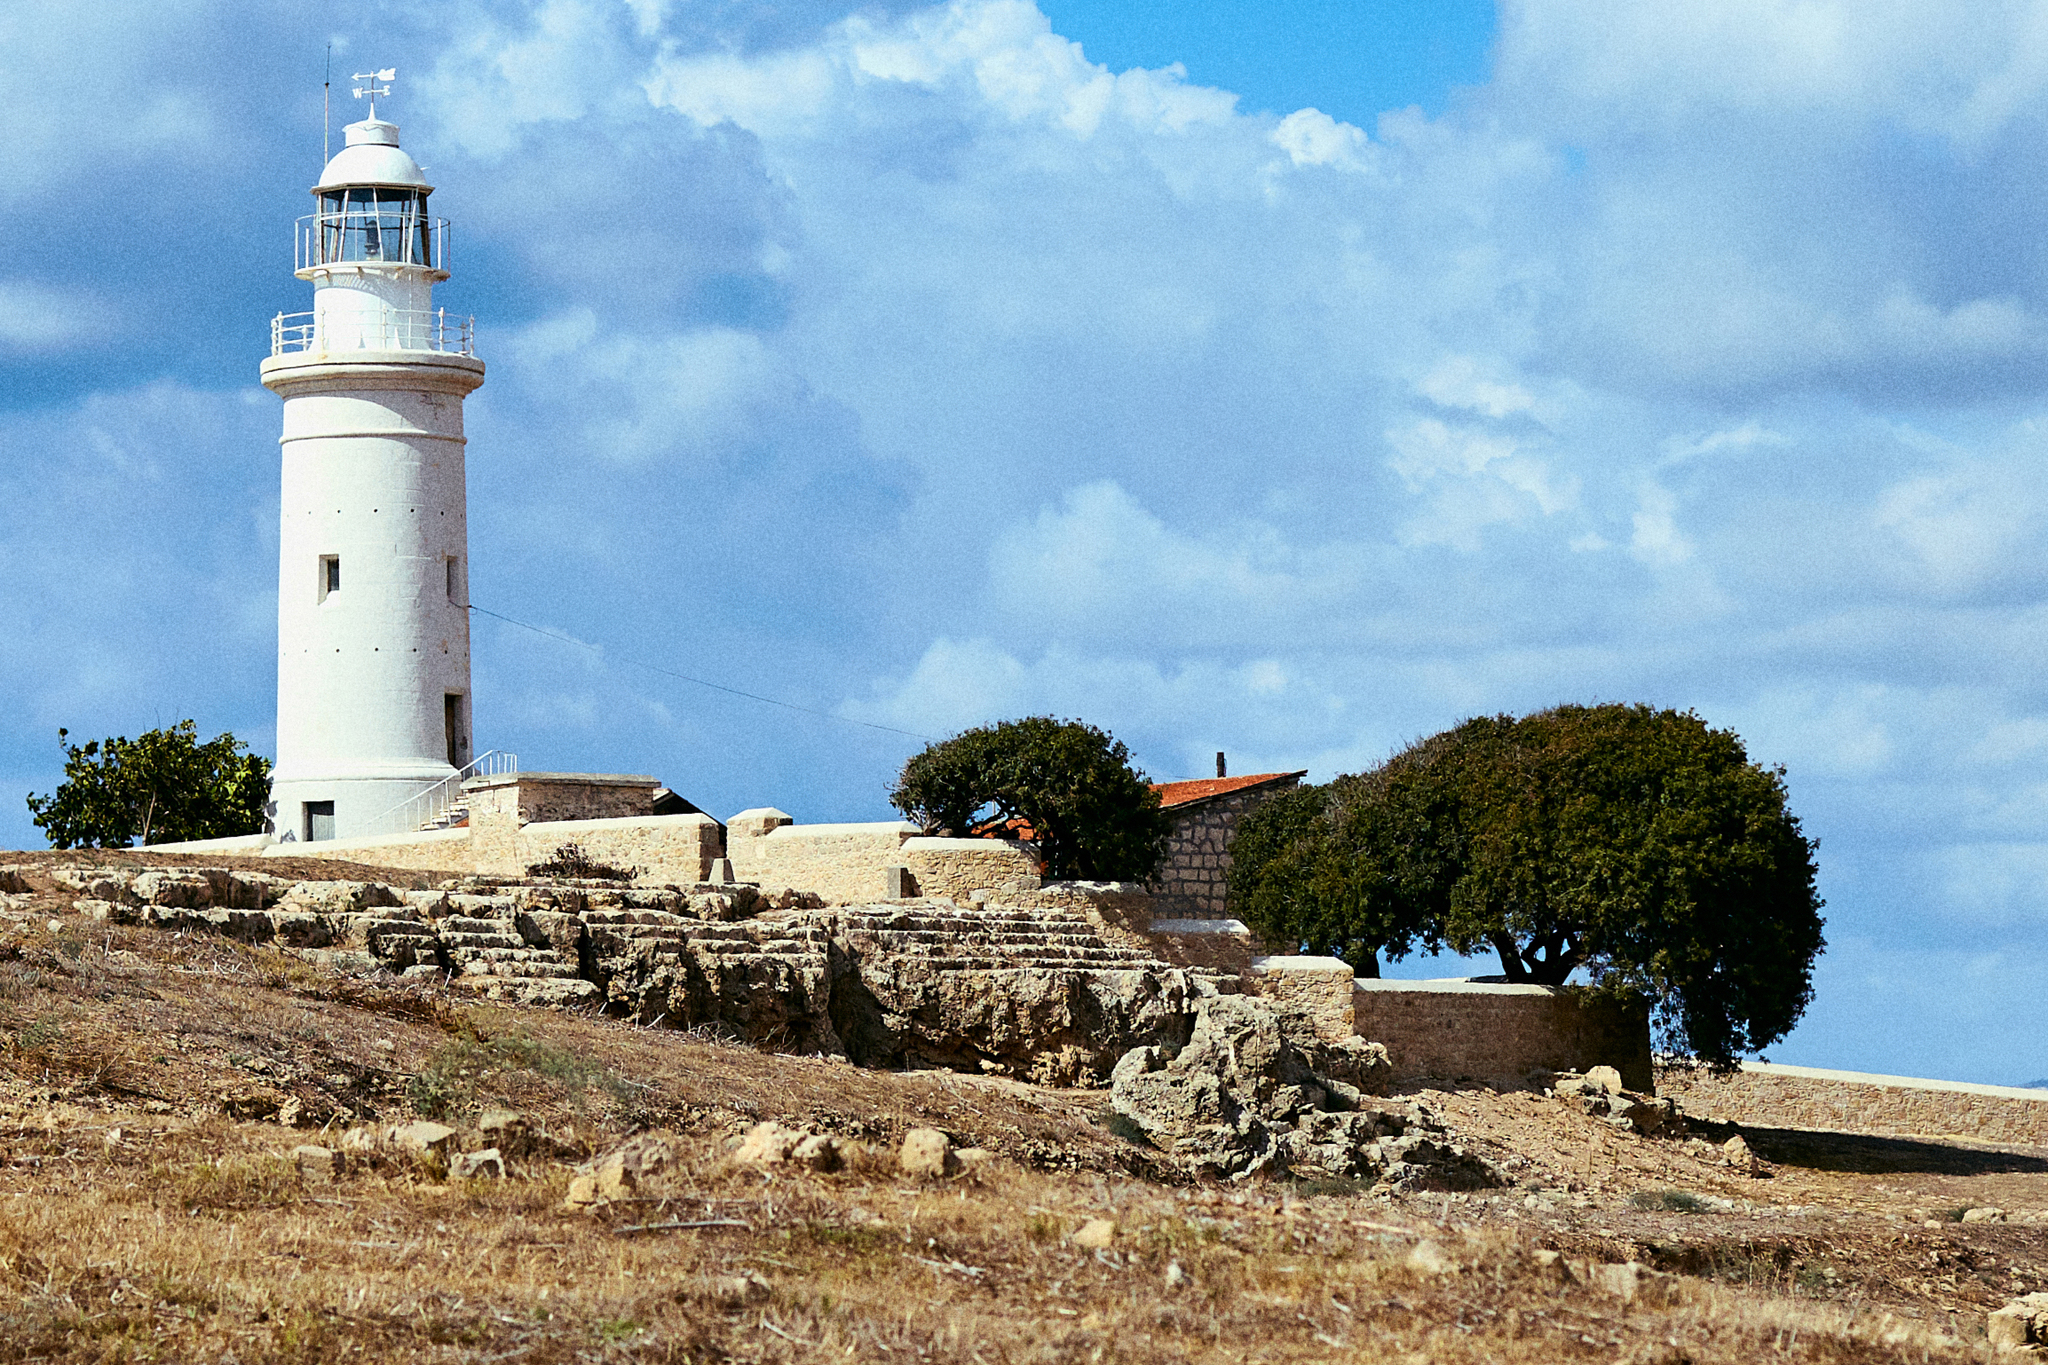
59,868,1233,1085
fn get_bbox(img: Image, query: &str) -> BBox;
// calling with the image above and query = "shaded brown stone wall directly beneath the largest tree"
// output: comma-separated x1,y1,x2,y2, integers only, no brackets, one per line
1351,978,1655,1091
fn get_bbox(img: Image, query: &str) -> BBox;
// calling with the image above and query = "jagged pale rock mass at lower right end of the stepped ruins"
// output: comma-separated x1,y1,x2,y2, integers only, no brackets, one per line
1110,995,1503,1191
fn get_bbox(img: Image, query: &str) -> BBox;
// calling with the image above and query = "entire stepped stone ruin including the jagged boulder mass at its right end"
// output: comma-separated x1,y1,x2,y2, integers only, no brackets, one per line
24,866,1501,1189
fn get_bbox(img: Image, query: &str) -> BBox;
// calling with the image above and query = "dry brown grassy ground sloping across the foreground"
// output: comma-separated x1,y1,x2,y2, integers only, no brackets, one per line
0,855,2048,1365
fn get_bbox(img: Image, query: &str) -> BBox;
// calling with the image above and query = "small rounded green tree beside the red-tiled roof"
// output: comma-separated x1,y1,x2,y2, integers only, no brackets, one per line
889,716,1174,882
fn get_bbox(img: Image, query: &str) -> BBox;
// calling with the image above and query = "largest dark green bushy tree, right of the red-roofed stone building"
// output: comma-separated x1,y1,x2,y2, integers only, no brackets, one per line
1231,706,1825,1064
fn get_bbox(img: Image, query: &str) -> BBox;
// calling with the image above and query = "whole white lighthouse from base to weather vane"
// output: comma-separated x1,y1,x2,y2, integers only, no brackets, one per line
262,72,483,839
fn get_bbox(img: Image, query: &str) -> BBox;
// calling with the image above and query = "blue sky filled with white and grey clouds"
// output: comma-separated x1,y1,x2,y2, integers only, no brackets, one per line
0,0,2048,1083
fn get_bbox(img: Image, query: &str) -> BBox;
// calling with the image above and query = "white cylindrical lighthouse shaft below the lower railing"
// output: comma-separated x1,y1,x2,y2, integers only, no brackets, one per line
262,350,483,843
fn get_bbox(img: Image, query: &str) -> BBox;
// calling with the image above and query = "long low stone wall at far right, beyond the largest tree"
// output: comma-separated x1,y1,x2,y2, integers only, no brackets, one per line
1657,1062,2048,1146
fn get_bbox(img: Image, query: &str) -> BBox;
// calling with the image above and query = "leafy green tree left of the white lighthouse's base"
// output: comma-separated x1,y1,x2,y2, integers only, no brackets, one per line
29,720,270,849
